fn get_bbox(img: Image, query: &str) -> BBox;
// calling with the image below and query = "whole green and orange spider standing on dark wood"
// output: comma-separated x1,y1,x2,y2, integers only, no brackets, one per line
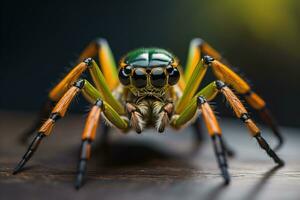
14,39,283,188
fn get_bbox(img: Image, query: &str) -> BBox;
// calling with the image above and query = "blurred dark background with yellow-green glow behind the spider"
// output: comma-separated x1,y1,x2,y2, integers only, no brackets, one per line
0,0,300,126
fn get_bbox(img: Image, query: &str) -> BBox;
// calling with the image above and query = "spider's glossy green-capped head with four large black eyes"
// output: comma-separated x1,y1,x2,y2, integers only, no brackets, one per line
119,48,180,96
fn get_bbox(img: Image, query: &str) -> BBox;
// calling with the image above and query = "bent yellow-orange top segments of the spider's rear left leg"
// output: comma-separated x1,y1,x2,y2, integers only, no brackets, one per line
78,38,119,90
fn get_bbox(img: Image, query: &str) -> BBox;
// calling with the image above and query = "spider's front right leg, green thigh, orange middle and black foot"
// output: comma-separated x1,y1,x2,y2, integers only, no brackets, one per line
171,96,230,184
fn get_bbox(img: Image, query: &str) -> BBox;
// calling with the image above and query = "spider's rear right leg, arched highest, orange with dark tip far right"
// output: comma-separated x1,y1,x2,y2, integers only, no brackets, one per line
184,38,283,149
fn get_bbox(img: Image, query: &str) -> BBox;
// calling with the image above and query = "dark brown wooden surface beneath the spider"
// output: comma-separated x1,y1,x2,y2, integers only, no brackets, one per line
0,111,300,200
